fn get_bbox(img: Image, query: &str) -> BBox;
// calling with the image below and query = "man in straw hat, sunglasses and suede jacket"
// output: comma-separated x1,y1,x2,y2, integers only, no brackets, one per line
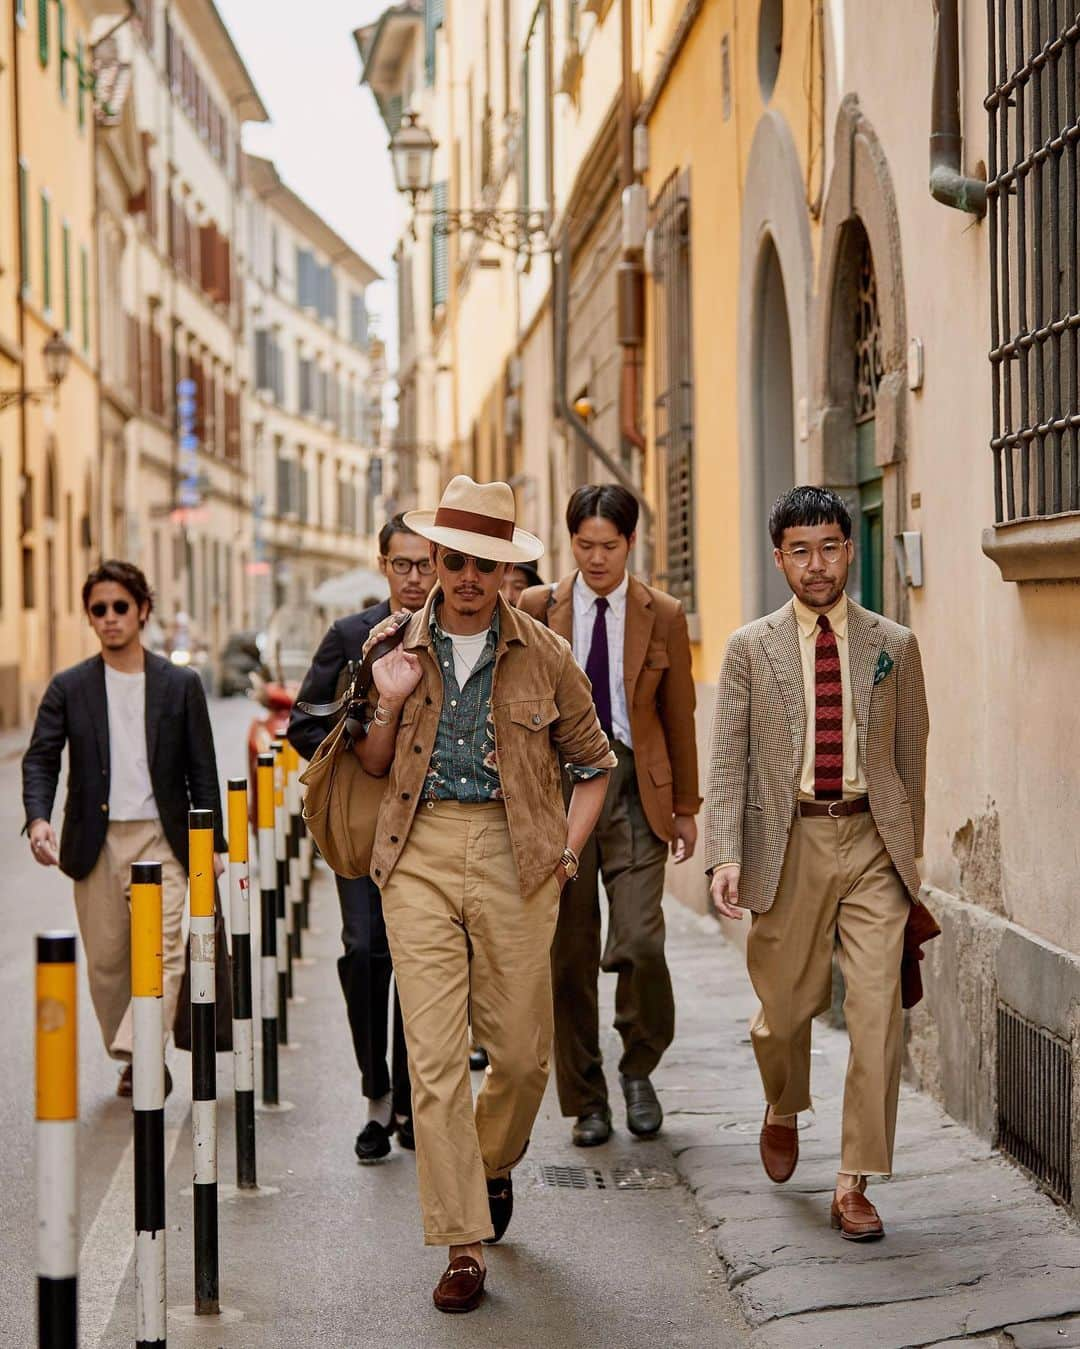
356,476,615,1311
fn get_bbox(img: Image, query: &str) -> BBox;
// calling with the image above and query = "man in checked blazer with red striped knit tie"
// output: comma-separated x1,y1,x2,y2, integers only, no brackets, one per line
705,487,929,1241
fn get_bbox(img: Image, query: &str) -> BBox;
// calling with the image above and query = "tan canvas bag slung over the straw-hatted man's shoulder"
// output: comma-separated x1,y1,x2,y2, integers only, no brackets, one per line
297,623,407,880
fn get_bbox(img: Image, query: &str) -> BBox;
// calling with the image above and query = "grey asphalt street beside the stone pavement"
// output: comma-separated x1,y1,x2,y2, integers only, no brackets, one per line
0,699,748,1349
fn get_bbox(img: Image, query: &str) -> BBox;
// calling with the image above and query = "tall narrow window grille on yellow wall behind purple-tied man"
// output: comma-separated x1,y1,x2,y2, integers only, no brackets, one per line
651,171,697,612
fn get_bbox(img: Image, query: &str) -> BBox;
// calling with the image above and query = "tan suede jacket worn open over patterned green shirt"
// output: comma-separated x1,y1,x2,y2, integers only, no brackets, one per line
371,587,616,897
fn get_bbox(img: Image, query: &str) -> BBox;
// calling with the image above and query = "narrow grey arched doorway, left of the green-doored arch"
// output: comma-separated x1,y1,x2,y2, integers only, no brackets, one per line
754,235,796,614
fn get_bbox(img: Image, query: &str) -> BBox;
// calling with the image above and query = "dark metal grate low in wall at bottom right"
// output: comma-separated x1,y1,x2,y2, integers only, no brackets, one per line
998,1002,1072,1203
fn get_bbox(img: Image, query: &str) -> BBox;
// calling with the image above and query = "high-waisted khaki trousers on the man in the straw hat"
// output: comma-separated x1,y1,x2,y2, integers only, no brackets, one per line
383,801,558,1246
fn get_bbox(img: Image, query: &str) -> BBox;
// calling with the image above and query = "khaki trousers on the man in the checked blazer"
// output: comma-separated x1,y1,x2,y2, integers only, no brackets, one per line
747,813,910,1175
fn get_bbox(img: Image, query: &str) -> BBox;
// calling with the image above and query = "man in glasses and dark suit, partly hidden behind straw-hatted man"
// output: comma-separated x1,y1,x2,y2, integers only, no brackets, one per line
289,515,436,1164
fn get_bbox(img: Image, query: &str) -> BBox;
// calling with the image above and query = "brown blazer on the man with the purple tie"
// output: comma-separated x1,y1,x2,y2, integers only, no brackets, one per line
519,572,701,843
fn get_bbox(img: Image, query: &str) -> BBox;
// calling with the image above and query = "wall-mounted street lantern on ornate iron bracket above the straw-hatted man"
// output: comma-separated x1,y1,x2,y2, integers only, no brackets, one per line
390,112,550,254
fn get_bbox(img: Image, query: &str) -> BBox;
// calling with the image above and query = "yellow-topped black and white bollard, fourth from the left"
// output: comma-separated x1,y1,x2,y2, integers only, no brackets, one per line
229,777,258,1190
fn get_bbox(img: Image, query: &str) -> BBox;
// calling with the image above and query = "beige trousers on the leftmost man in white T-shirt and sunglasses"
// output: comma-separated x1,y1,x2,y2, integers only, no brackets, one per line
76,820,187,1059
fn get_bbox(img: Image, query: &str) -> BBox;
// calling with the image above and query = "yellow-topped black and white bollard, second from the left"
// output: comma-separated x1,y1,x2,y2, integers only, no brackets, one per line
131,862,166,1349
